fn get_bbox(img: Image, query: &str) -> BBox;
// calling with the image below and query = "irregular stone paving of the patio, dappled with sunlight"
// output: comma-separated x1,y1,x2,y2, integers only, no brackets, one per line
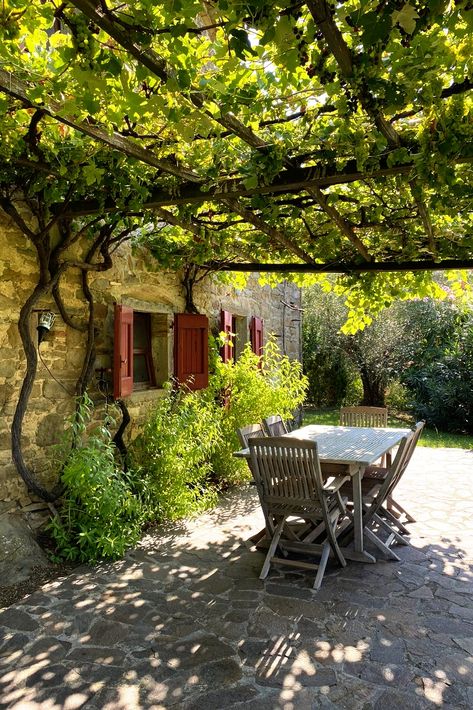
0,448,473,710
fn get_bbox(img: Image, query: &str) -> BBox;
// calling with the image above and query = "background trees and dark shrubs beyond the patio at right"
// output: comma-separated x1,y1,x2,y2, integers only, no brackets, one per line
303,275,473,432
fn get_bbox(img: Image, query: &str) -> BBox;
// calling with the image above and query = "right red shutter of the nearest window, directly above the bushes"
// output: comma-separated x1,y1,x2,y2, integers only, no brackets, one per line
174,313,209,390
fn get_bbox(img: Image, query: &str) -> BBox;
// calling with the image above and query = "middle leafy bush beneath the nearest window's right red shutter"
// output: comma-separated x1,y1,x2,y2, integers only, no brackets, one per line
130,387,221,520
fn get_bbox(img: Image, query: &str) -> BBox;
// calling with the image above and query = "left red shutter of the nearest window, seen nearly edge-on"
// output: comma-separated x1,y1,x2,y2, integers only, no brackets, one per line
113,304,133,399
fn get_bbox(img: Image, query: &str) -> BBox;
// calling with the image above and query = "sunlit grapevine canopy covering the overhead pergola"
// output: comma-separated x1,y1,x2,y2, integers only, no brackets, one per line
0,0,473,323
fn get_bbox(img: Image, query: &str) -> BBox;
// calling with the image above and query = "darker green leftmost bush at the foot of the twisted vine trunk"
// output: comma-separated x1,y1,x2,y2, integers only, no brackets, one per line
49,395,143,561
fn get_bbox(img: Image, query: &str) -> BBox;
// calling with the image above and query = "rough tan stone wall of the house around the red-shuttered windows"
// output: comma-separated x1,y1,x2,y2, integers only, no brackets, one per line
0,214,300,519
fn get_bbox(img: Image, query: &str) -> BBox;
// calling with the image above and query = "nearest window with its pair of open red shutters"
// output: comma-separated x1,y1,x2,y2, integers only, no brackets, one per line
113,304,208,399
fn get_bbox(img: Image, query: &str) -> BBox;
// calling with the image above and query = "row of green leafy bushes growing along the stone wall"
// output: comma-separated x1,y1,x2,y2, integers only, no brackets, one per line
51,341,306,561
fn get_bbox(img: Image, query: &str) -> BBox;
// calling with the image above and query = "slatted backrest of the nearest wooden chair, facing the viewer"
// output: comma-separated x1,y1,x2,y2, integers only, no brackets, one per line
249,436,327,517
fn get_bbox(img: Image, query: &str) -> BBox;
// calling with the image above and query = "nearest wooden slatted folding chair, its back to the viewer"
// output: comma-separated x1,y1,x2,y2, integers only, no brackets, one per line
249,437,348,589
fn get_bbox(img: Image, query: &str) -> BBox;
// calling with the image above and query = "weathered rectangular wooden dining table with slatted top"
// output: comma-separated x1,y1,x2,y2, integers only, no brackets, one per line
234,424,411,562
